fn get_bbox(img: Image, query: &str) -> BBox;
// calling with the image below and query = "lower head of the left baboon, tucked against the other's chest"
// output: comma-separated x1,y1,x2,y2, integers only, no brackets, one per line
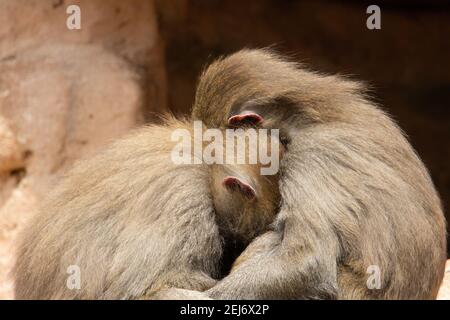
210,129,284,242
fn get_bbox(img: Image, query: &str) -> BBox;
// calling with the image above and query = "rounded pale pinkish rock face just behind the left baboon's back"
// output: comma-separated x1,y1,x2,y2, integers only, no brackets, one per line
0,45,143,179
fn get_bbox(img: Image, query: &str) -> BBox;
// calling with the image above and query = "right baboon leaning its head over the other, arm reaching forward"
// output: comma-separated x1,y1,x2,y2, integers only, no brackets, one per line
192,49,446,299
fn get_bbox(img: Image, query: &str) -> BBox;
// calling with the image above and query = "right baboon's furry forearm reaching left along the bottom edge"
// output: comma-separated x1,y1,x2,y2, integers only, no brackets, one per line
205,222,337,299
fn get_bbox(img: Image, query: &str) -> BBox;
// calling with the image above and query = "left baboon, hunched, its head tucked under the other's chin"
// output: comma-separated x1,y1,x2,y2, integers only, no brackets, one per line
14,118,279,299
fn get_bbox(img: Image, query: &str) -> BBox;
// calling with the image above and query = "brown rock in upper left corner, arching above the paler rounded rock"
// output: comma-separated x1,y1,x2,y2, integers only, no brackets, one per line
0,0,166,114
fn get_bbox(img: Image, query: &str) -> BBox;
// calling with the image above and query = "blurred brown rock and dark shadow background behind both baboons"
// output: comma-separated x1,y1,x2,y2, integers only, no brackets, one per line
0,0,450,299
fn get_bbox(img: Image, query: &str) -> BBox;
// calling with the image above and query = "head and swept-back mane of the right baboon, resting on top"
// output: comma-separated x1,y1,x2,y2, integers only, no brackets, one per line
192,49,370,140
